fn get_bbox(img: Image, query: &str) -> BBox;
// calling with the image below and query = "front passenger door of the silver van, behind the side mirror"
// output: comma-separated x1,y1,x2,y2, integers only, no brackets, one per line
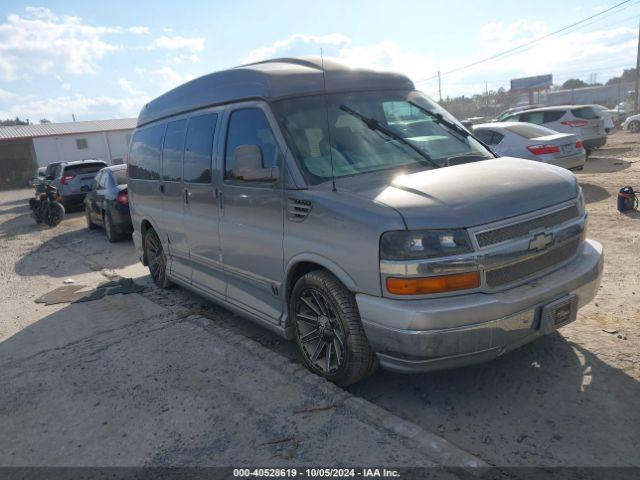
219,102,284,323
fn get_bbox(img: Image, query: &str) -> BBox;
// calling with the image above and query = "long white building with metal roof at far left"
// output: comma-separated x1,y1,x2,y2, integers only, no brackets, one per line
0,118,136,189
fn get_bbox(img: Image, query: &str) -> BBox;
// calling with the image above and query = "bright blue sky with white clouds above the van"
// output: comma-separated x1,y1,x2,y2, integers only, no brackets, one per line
0,0,640,122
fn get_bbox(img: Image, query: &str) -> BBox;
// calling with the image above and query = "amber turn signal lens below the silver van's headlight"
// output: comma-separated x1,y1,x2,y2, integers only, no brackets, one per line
387,272,480,295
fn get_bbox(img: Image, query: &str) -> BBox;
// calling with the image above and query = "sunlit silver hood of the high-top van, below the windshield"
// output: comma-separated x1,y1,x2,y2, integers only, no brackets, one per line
354,157,578,229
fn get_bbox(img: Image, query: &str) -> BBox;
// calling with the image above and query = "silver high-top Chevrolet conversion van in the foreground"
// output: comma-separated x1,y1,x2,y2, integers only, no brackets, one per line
128,59,603,385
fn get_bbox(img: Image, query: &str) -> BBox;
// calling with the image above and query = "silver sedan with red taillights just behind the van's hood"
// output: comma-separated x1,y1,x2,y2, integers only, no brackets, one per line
473,122,587,170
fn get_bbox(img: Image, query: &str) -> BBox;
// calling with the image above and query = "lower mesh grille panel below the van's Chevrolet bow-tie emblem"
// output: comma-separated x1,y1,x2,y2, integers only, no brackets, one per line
485,237,580,287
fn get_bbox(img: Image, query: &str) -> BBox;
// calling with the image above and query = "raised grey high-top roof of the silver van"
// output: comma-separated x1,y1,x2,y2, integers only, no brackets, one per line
138,57,415,127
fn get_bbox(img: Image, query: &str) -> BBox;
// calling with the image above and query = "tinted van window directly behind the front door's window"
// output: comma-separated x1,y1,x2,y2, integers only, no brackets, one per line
183,113,218,183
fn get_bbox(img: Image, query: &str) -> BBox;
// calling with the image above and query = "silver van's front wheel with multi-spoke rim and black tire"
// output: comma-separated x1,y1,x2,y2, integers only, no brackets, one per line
289,270,377,387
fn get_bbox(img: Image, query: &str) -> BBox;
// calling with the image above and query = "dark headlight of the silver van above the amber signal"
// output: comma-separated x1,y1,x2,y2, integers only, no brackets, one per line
380,230,473,260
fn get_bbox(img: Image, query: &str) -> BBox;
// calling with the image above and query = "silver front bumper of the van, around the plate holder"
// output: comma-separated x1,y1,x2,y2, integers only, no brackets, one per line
356,240,604,373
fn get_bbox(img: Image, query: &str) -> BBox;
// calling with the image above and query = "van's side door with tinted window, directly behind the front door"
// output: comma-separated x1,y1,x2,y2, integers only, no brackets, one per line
183,112,226,299
